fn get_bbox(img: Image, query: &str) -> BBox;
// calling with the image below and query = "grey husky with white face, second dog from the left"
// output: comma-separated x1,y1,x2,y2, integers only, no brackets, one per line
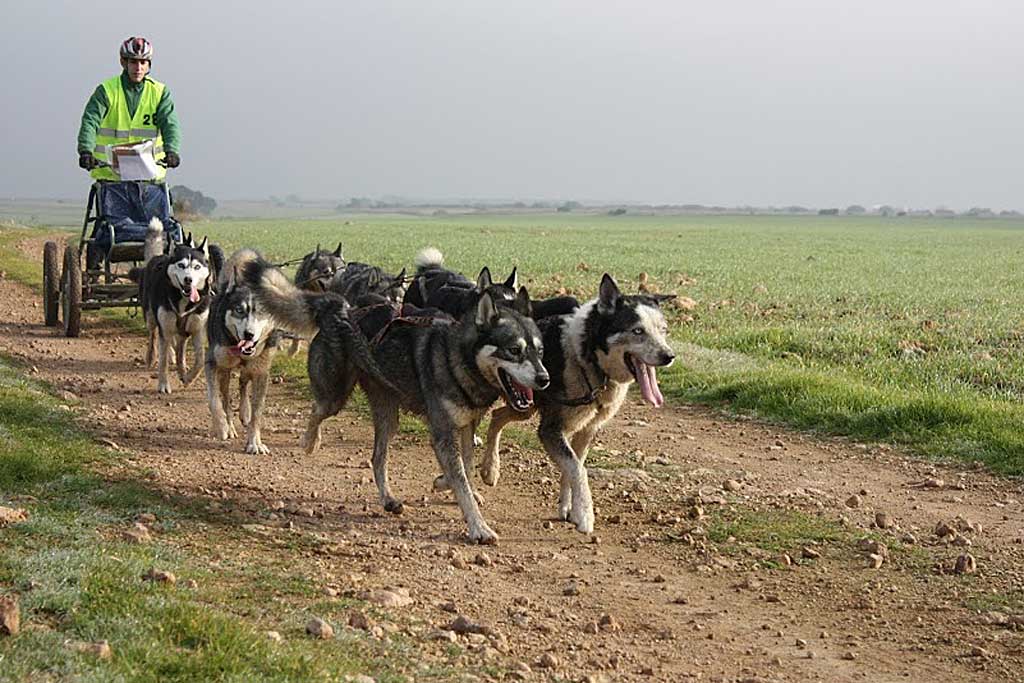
206,249,282,455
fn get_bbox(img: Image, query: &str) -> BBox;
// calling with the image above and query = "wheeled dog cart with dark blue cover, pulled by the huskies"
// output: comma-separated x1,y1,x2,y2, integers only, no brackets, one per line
43,166,182,337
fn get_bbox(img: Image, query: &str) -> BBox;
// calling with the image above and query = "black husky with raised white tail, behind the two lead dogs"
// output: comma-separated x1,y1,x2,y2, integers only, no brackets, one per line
403,247,519,319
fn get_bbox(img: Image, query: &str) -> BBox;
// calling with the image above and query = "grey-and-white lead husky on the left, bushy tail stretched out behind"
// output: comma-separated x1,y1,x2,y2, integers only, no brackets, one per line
239,252,549,543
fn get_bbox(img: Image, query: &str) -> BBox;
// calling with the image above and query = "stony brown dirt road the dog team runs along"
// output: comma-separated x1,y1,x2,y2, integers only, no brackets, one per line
0,233,1024,683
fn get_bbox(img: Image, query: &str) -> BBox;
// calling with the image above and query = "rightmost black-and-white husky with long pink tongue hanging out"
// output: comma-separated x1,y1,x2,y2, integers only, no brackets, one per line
475,273,676,533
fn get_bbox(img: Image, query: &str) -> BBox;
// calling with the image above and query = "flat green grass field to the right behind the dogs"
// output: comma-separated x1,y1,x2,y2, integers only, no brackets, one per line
6,214,1024,475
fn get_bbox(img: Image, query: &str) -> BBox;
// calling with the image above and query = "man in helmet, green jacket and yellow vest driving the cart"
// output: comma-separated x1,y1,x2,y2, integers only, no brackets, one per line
78,36,181,181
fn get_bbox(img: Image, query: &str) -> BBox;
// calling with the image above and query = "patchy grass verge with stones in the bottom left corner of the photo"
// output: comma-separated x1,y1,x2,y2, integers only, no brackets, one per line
0,359,432,681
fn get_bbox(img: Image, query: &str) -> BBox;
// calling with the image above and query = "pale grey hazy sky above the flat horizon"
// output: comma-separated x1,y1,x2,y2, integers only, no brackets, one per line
0,0,1024,209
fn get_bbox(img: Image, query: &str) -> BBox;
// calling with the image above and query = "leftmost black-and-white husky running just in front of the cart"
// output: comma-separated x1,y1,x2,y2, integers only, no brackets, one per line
129,223,223,393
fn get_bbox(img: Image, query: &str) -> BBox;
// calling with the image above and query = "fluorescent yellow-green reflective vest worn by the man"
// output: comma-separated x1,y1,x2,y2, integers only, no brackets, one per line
91,75,167,181
